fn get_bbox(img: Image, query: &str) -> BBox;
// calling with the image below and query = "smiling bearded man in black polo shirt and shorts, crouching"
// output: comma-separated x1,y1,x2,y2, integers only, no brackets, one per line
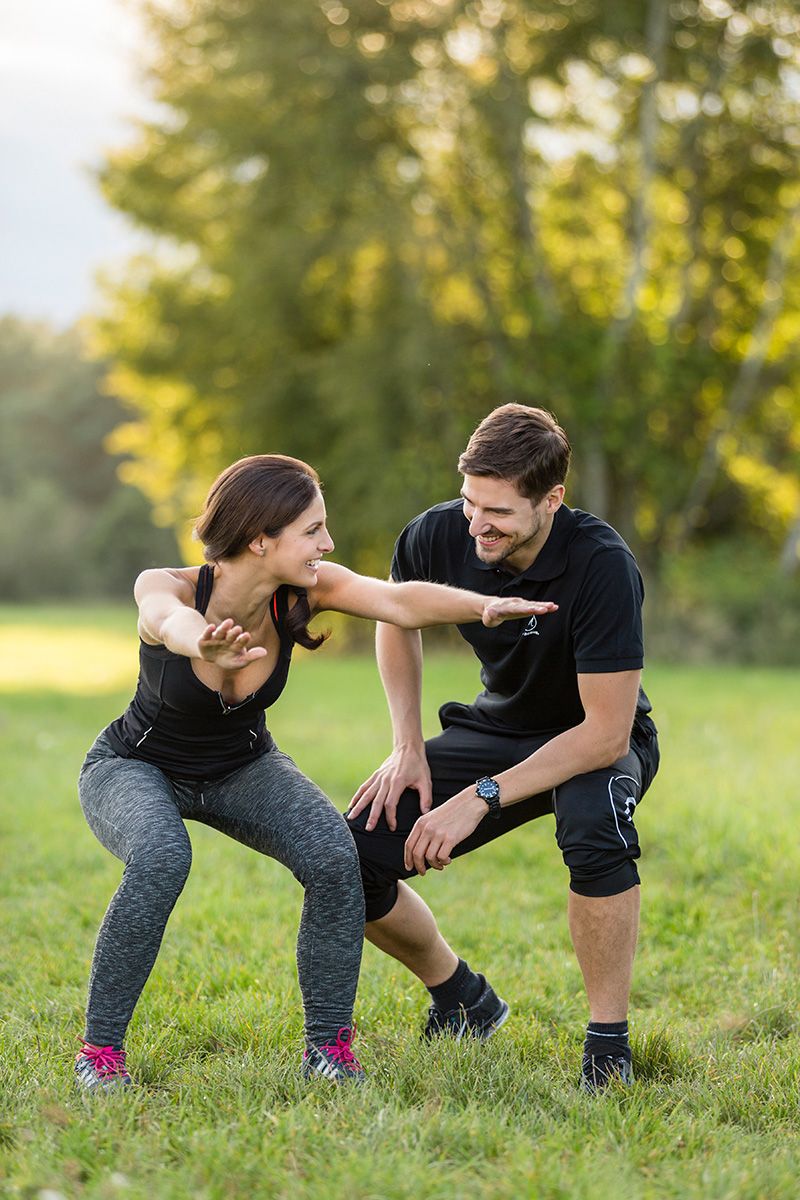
349,404,658,1092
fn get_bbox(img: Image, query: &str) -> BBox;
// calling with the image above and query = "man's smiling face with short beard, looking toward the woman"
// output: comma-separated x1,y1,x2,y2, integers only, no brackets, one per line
461,475,564,574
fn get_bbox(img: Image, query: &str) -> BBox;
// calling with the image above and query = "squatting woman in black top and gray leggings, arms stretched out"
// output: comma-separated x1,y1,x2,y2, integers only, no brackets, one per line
76,455,554,1092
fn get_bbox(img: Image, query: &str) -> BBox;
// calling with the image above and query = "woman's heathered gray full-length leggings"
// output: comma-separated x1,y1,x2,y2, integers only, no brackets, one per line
78,733,363,1046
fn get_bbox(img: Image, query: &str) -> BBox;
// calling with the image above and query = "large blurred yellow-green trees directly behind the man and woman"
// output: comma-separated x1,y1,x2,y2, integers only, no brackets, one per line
97,0,800,570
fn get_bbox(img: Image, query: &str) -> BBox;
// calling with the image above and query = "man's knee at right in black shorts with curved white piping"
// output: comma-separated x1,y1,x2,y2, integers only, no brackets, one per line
554,768,640,896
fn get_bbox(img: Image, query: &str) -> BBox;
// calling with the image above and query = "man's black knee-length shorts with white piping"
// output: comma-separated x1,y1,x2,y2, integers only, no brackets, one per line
349,718,658,920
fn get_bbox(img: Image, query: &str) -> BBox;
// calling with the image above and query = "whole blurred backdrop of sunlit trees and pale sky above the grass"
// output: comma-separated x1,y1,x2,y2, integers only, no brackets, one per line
0,0,800,664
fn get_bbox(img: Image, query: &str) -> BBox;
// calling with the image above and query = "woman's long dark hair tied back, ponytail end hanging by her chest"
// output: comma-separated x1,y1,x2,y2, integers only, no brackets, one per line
194,454,329,650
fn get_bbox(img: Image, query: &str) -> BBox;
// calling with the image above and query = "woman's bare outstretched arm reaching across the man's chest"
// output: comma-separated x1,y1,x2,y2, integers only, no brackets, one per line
308,563,558,629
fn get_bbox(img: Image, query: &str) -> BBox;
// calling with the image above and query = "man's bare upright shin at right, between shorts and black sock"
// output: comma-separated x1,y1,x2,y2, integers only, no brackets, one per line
567,887,639,1022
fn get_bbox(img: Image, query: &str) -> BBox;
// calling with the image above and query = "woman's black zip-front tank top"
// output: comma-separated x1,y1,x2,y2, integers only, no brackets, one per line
106,566,294,780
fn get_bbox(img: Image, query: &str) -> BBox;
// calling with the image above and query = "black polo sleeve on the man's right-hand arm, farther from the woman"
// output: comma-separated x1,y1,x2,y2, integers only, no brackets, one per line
572,547,644,674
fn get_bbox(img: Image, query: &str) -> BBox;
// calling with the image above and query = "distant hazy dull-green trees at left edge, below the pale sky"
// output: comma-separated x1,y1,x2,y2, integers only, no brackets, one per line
0,317,178,601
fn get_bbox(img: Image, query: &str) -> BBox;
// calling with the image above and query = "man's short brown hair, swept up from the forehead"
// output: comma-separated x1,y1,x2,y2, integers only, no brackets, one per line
458,404,572,503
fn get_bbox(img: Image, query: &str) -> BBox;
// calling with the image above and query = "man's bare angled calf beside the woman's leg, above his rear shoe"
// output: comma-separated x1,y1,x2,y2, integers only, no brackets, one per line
366,882,458,988
